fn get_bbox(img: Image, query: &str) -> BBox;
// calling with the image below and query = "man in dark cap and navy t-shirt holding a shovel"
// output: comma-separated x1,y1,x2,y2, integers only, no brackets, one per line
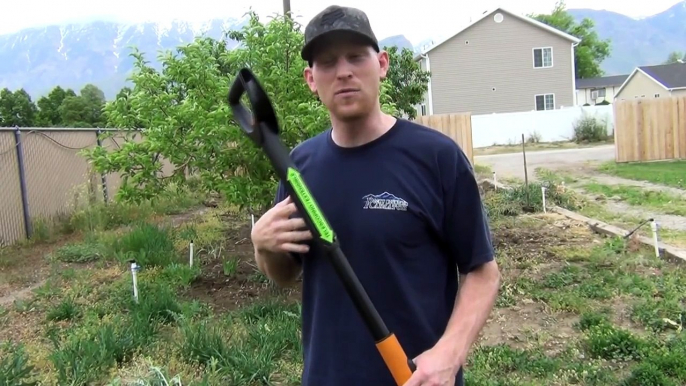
252,6,500,386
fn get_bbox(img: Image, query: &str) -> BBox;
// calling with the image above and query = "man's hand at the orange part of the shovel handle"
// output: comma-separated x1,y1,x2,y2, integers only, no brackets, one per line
403,343,463,386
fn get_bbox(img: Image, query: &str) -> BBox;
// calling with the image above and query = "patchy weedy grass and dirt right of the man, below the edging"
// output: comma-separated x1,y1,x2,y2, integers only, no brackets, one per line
466,210,686,385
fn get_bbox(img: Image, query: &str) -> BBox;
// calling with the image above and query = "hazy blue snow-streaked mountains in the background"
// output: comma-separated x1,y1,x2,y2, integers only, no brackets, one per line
0,0,686,100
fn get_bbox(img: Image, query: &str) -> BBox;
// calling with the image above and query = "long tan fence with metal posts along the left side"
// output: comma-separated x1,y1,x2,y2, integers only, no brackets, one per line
0,127,171,246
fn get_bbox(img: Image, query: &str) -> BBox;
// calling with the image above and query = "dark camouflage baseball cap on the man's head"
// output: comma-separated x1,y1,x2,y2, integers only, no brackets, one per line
300,5,379,62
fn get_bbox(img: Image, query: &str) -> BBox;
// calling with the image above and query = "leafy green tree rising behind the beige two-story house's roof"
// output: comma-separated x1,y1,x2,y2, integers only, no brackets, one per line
529,0,611,79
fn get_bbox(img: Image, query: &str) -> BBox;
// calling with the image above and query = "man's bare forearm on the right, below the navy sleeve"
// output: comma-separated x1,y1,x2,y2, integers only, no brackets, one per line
439,261,500,366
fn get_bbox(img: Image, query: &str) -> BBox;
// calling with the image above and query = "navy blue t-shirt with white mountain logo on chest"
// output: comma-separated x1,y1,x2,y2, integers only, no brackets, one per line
276,119,493,386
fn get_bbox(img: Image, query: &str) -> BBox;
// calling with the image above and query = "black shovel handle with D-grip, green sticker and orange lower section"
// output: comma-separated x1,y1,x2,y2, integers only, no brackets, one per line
228,68,415,386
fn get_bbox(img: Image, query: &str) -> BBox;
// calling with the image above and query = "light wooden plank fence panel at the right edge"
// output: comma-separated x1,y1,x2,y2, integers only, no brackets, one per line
614,97,686,162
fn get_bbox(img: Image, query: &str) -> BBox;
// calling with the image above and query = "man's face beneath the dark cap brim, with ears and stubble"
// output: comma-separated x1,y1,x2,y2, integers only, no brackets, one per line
305,35,389,121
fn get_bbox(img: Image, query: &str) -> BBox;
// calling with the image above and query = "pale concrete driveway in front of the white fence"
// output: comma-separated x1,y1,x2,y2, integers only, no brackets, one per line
474,145,615,180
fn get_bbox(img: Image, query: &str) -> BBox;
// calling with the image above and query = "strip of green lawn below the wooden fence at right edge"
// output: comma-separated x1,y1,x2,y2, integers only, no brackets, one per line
598,161,686,189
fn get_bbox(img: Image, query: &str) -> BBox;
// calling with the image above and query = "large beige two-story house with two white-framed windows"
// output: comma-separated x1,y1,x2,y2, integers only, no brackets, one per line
415,8,580,115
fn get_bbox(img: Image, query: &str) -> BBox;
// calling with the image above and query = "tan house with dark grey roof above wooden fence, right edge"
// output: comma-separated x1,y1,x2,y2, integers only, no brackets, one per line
615,63,686,100
